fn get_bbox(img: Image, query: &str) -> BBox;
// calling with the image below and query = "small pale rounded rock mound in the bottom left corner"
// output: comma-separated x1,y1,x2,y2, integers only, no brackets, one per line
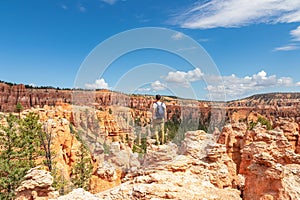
16,167,59,200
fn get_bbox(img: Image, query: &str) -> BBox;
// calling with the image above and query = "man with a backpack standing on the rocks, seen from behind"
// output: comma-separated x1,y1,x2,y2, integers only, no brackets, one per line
152,94,166,145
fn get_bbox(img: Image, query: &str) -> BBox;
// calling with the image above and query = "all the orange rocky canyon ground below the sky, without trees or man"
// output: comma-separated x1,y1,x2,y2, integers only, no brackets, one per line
0,83,300,200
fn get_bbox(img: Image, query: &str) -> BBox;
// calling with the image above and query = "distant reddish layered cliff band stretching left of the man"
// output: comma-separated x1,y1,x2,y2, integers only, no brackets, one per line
0,82,148,112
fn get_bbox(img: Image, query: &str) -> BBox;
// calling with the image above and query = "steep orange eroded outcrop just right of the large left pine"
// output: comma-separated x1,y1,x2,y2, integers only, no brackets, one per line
21,105,126,193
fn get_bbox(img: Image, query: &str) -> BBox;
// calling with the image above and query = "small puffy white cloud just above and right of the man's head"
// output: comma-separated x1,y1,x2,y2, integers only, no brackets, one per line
165,68,203,87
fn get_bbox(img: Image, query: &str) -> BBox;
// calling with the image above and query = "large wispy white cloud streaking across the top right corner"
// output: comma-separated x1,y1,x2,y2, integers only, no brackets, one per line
175,0,300,29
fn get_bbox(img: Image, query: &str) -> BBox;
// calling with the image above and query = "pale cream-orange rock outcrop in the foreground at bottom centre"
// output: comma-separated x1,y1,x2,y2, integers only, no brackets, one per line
97,131,241,199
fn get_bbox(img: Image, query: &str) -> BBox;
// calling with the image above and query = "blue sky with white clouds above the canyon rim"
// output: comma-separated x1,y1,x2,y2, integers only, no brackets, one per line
0,0,300,100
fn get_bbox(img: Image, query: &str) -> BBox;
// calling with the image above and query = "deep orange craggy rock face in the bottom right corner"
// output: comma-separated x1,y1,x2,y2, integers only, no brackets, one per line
218,118,300,200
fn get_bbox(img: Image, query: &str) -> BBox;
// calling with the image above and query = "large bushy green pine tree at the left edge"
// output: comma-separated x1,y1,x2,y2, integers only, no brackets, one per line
0,113,47,199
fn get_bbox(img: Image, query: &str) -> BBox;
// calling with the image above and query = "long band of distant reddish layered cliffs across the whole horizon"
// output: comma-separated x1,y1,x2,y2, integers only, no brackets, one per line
0,83,300,131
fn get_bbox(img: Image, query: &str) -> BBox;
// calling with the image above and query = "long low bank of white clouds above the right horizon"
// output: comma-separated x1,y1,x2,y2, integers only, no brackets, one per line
206,71,300,99
